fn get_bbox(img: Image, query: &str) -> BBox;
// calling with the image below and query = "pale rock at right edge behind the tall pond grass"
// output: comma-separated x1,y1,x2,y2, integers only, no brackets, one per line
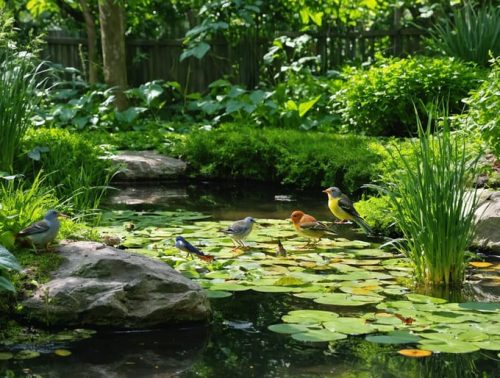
472,192,500,254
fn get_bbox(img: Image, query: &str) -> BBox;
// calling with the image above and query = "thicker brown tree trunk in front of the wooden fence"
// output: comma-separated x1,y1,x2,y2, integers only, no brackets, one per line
99,0,127,110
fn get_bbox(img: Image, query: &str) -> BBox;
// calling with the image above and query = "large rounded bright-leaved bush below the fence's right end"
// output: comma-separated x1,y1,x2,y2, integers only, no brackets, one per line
333,57,483,136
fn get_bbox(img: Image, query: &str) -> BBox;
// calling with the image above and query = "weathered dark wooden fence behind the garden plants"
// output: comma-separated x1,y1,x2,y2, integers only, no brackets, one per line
44,29,423,92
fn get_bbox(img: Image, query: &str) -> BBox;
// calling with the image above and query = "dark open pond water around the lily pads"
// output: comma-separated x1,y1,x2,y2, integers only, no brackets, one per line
0,182,500,378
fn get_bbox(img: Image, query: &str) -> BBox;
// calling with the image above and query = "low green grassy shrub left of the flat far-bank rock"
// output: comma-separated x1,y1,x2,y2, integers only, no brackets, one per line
19,128,113,210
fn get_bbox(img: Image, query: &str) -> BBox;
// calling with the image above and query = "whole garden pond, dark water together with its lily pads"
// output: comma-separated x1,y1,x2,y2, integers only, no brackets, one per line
0,182,500,378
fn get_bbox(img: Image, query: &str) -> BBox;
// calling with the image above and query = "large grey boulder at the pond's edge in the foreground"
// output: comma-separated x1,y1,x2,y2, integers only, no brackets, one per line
23,242,211,329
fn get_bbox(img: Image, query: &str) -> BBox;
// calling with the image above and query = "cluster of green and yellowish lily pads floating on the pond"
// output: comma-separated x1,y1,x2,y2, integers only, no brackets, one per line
100,210,500,356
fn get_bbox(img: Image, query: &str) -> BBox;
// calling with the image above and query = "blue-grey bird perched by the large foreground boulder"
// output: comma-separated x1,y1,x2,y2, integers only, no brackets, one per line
16,209,66,253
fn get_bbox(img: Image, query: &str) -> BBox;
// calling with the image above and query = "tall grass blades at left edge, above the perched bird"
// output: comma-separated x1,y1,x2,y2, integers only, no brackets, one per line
0,14,41,172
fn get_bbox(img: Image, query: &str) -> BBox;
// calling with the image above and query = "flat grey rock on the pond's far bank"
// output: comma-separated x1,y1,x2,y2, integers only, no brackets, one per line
109,151,187,181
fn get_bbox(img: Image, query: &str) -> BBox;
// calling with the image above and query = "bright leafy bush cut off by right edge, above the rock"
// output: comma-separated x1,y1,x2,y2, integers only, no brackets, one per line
464,58,500,156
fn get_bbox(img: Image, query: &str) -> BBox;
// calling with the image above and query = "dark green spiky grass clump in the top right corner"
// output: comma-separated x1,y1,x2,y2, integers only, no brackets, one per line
431,3,500,66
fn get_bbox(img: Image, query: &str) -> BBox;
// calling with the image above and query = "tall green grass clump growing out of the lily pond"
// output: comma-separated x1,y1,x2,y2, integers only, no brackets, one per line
379,108,480,286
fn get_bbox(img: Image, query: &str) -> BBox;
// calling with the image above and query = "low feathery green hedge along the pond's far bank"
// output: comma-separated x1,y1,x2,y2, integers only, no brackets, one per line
176,124,380,192
